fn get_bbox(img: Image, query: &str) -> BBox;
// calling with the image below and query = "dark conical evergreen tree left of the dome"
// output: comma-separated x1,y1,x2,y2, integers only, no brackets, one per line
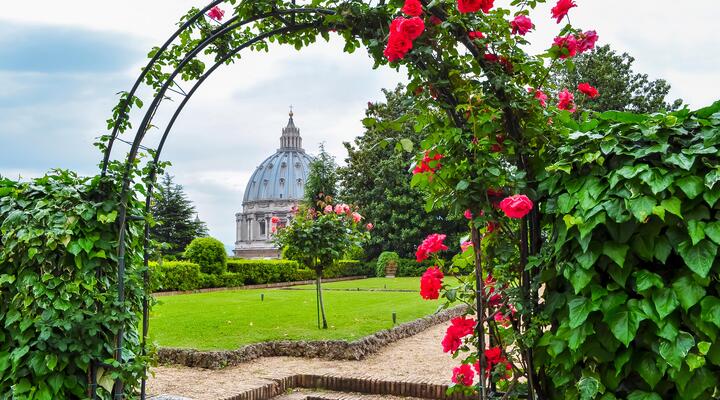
150,174,207,255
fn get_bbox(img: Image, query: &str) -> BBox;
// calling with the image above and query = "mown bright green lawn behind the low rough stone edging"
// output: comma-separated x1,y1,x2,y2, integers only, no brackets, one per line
150,278,439,350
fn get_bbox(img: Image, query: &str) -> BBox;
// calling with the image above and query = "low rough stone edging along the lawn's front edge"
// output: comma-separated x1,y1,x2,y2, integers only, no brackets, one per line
158,306,466,369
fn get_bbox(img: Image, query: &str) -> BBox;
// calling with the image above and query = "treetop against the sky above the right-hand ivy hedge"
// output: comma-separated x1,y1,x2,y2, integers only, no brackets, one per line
553,45,682,113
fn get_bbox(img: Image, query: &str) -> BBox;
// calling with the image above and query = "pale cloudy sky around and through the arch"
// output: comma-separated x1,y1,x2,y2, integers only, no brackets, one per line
0,0,720,250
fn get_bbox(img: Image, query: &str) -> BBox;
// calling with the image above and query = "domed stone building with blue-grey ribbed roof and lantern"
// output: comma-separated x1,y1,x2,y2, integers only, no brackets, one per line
234,111,312,258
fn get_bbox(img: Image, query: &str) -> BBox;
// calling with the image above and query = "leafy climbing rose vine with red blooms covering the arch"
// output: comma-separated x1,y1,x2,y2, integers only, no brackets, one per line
93,0,597,398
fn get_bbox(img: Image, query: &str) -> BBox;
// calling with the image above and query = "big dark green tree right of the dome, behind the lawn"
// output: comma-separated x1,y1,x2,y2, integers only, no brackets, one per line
338,85,467,259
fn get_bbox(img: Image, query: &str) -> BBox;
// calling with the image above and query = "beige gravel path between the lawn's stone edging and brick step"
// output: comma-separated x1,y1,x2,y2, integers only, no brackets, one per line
148,322,456,400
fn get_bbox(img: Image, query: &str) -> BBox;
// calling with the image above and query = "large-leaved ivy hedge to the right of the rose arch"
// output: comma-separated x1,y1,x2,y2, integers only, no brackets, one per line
536,102,720,399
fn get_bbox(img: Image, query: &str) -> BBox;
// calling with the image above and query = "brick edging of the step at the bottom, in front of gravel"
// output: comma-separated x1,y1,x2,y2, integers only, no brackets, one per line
223,375,475,400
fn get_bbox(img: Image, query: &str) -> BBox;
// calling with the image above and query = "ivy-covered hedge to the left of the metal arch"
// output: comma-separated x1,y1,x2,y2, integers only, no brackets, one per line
0,171,148,400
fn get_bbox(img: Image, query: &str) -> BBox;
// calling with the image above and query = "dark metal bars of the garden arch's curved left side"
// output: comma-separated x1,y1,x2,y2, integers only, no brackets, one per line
97,0,335,400
